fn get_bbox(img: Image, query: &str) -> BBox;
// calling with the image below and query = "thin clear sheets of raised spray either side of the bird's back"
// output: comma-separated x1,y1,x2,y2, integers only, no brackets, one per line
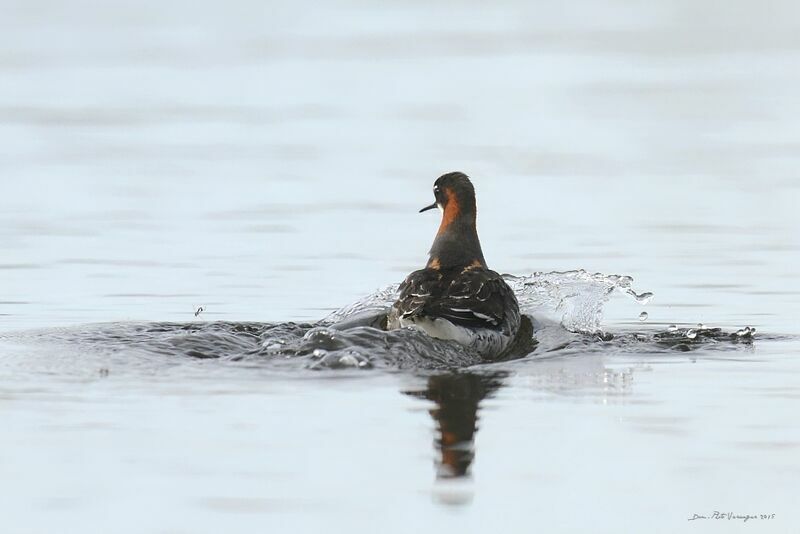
322,269,653,334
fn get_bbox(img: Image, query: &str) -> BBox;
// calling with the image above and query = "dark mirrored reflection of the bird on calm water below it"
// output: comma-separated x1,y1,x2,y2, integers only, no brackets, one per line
405,372,506,480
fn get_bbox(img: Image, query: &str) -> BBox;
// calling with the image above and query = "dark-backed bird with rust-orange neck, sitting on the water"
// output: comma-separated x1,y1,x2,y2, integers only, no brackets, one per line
386,172,521,359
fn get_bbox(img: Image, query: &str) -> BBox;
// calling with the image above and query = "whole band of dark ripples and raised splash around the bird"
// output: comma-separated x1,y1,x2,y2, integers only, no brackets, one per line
9,270,768,372
